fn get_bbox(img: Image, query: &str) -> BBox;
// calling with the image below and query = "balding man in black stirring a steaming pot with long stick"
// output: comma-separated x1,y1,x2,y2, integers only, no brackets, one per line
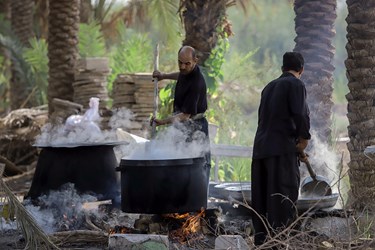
151,46,211,178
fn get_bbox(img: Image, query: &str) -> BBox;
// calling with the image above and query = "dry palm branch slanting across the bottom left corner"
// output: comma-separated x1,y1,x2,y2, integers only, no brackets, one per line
0,164,59,249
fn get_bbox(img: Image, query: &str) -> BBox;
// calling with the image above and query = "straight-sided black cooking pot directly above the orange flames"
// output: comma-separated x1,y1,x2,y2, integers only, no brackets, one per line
117,157,210,214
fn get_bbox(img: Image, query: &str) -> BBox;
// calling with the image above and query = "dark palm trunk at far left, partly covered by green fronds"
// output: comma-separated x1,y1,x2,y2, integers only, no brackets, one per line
10,0,35,109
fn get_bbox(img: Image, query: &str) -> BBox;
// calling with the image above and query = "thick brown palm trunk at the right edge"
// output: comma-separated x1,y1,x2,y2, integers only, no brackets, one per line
345,0,375,209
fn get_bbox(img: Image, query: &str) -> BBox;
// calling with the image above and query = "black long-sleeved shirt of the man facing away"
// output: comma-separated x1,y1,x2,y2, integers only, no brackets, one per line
253,72,311,159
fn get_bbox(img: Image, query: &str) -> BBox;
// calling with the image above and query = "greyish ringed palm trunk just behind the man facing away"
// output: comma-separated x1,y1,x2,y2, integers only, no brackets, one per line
294,0,337,143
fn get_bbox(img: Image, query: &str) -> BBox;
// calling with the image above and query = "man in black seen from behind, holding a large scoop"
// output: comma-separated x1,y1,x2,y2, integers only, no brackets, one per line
251,52,311,245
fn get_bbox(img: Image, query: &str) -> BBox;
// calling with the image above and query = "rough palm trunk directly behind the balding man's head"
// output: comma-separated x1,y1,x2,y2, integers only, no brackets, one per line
180,0,227,65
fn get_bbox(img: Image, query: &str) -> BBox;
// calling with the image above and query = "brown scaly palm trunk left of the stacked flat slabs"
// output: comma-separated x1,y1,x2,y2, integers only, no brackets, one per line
48,0,80,114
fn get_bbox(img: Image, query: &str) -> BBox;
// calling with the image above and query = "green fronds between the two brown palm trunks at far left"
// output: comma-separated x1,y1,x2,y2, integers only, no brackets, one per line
23,38,48,105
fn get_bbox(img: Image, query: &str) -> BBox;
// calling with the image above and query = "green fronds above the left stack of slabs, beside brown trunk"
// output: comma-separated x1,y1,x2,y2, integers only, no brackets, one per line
78,22,106,57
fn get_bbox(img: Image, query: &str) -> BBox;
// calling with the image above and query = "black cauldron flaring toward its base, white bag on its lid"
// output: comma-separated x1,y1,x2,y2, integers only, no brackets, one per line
25,145,120,201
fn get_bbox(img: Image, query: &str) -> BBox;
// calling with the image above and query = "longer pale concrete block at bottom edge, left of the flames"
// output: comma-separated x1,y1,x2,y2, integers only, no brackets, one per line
108,234,169,250
